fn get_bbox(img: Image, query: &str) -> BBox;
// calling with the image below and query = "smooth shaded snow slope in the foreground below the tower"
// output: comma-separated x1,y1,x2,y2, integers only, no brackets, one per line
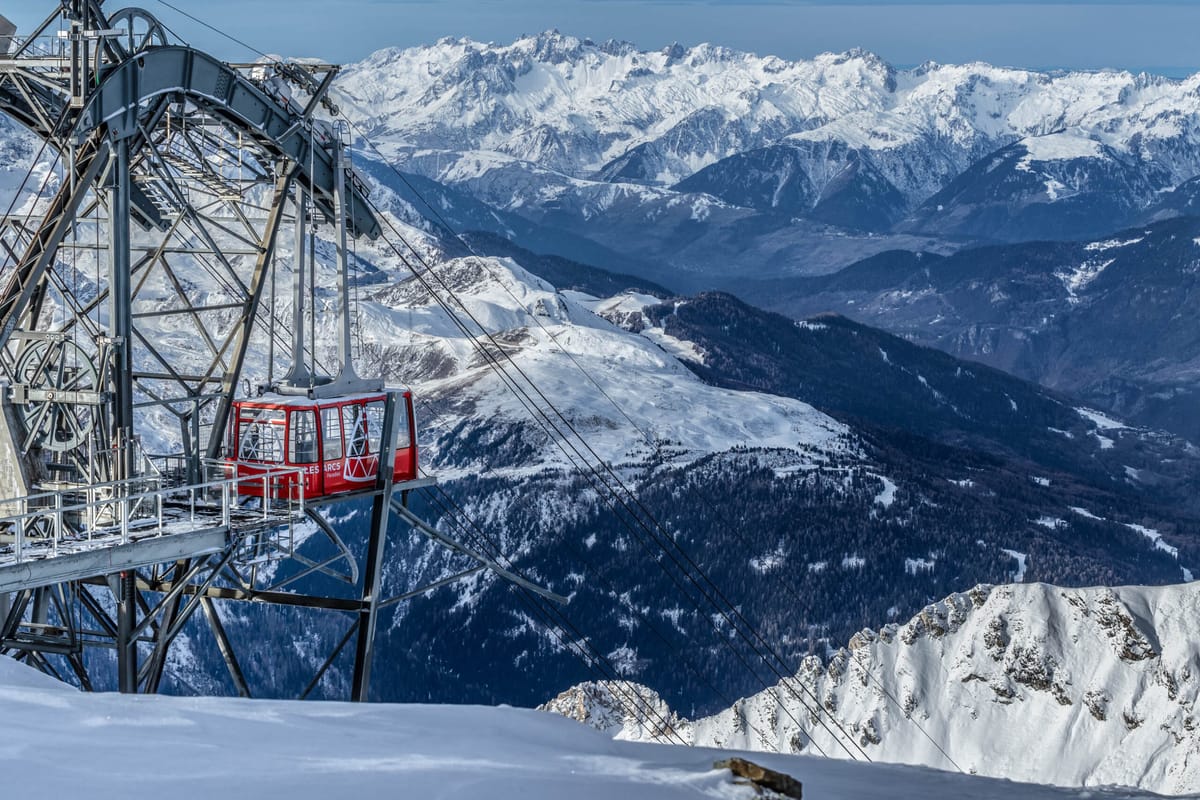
0,657,1166,800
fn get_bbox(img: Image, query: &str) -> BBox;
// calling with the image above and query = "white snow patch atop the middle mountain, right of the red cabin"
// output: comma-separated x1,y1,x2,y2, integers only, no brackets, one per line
374,258,856,479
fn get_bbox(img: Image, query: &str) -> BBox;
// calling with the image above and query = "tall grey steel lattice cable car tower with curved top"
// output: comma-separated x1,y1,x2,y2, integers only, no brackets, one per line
0,0,482,700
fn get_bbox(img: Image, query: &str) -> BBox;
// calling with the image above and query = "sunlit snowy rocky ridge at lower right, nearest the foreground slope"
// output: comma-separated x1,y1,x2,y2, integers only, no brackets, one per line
544,584,1200,794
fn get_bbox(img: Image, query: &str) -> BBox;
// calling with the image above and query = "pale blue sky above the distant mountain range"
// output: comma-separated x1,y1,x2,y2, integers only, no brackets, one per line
6,0,1200,74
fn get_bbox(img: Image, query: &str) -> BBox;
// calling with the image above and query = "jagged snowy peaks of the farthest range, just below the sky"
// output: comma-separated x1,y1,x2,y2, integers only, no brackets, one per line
340,31,1200,190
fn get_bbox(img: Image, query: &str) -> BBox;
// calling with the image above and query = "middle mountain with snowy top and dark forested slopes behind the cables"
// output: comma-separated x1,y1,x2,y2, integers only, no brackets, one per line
166,239,1198,711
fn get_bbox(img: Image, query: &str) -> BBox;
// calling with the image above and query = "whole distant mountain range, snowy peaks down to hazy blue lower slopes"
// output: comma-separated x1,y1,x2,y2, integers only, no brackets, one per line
338,31,1200,290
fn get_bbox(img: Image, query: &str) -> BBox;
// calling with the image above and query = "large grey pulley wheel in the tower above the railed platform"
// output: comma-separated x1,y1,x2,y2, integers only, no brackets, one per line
14,339,100,452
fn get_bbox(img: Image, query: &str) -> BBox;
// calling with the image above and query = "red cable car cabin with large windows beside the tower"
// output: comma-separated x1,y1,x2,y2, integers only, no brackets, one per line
226,391,416,500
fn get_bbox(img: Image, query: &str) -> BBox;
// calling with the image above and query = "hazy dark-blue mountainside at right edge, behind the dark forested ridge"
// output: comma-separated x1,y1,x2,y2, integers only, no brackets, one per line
743,216,1200,441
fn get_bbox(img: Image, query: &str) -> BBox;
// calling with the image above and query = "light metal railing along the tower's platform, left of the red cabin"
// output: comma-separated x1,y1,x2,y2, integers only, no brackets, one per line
0,463,305,564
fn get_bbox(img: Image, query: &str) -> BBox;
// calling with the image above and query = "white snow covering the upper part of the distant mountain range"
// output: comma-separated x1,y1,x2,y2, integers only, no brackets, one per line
337,37,1200,208
